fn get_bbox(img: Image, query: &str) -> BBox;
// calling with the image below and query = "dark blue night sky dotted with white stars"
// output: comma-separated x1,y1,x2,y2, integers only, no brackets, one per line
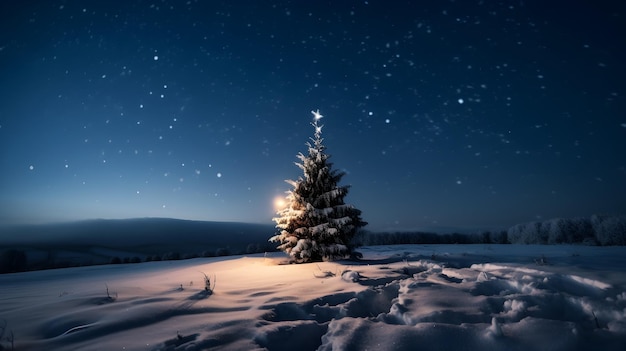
0,0,626,234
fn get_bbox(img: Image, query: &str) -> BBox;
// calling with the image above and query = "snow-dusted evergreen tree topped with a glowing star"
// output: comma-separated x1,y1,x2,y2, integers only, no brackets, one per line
270,110,367,263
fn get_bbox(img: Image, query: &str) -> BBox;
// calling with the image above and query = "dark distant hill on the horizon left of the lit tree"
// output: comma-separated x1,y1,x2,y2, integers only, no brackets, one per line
0,218,276,269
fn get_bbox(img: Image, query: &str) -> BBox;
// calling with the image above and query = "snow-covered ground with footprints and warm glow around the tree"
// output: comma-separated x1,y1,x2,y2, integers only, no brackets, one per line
0,245,626,351
